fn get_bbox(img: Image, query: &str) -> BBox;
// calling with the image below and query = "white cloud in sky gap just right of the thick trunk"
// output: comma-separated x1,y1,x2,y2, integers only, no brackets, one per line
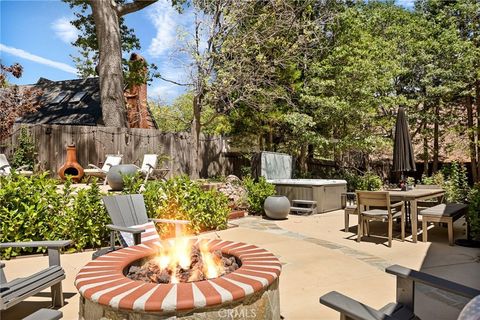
148,0,182,58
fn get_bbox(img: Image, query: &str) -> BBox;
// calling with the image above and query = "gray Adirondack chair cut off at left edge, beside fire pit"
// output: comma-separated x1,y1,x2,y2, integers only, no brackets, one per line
0,240,72,312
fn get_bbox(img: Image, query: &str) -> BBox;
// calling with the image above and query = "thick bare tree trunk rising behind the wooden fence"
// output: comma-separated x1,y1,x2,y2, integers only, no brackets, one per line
90,0,127,128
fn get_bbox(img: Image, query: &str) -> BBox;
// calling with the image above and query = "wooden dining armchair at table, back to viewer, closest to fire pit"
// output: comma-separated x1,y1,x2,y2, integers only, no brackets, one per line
357,191,405,247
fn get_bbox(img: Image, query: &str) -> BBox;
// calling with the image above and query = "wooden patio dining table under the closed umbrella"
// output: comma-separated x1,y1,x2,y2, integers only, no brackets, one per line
388,189,445,242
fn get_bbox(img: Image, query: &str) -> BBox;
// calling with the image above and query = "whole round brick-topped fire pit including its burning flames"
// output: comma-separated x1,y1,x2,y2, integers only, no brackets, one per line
75,239,281,320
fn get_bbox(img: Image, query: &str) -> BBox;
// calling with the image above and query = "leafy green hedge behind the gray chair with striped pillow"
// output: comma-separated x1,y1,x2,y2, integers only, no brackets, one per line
0,172,230,259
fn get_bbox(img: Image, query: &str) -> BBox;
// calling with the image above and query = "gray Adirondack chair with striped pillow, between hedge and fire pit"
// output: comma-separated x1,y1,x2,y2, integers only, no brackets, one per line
93,194,190,259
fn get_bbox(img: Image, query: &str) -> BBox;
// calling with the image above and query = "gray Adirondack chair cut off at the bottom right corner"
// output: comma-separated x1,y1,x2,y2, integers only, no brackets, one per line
320,265,480,320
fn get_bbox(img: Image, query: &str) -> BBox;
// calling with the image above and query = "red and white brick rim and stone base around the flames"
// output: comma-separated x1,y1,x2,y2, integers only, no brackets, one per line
75,239,281,320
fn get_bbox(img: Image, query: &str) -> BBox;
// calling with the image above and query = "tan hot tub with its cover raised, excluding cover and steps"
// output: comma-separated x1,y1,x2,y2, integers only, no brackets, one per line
267,179,347,213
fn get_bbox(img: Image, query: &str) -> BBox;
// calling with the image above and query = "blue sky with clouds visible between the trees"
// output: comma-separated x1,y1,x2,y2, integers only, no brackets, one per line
0,0,413,103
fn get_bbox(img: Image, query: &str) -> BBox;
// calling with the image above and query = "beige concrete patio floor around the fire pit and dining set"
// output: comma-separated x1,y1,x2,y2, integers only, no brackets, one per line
0,210,480,320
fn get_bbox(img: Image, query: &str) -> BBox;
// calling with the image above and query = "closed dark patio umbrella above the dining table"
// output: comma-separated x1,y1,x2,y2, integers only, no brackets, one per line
393,107,416,179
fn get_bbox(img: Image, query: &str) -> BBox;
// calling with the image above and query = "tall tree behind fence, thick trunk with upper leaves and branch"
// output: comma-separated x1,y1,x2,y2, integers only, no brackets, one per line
64,0,157,127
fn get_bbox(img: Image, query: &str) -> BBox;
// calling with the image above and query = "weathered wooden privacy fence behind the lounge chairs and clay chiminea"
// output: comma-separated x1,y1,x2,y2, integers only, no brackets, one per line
0,124,240,177
